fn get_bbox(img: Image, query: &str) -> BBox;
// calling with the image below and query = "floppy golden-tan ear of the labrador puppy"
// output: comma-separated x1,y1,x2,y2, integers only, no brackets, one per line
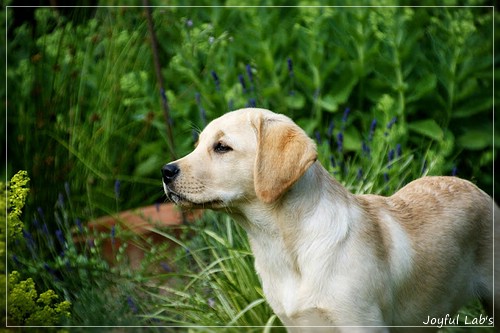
254,115,317,203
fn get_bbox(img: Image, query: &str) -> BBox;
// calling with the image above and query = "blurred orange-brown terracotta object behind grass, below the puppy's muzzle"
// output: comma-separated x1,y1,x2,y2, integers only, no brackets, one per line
75,203,203,268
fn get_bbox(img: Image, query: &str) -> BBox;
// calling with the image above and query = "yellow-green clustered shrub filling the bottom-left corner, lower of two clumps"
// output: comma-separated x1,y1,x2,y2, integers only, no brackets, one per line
8,271,71,326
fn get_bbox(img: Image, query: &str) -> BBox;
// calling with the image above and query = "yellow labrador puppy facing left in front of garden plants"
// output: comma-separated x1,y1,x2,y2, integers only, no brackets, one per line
162,109,499,332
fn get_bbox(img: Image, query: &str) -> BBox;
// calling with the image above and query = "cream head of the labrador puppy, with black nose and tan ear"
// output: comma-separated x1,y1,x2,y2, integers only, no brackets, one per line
162,108,317,208
